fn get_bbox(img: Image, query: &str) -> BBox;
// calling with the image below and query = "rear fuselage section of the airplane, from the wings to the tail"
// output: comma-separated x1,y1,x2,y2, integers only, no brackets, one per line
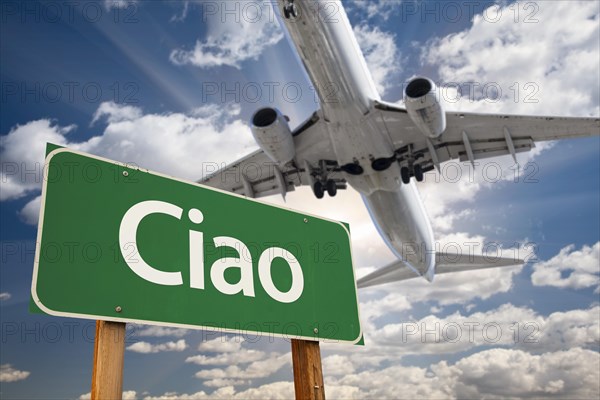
363,183,435,277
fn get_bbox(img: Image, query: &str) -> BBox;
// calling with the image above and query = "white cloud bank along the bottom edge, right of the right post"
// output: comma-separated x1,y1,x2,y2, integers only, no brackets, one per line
325,348,600,399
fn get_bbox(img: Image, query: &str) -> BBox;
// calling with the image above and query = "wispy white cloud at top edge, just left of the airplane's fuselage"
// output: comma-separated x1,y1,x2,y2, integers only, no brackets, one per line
170,1,283,69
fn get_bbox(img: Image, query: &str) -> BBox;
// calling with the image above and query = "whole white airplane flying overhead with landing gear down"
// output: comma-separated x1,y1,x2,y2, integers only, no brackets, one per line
198,0,600,288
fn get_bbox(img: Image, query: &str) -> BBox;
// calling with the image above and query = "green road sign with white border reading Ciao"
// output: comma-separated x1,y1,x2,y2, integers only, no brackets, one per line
32,148,361,343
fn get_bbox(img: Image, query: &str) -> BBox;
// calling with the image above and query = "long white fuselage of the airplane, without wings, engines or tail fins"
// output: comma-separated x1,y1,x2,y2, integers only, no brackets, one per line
279,0,435,279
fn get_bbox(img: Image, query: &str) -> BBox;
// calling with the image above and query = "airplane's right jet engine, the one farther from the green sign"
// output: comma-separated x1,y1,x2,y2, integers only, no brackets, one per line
404,78,446,139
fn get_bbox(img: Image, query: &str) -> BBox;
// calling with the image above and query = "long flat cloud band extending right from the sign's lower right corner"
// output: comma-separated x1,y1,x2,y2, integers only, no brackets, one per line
369,304,600,354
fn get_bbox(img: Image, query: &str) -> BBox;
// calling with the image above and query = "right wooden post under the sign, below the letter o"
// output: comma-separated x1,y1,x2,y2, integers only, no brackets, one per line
292,339,325,400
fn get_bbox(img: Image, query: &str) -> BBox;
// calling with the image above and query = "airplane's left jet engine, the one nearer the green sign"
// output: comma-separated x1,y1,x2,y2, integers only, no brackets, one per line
251,107,296,165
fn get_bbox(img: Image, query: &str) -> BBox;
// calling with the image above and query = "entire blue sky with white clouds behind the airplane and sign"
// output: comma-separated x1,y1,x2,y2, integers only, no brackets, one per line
0,0,600,398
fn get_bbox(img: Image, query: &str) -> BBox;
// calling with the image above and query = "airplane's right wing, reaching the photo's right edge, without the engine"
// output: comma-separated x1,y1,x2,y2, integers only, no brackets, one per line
374,102,600,172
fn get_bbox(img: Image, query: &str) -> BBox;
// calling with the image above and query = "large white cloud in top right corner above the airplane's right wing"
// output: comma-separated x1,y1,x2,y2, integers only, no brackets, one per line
423,1,600,116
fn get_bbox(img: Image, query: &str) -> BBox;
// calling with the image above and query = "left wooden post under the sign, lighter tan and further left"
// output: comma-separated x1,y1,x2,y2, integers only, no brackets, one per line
92,321,125,400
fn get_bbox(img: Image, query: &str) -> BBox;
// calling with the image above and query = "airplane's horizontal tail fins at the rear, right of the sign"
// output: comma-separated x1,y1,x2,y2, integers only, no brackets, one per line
356,253,525,289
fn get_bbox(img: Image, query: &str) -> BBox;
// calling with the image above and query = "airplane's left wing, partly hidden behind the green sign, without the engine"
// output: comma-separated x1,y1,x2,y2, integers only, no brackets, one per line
198,112,346,198
